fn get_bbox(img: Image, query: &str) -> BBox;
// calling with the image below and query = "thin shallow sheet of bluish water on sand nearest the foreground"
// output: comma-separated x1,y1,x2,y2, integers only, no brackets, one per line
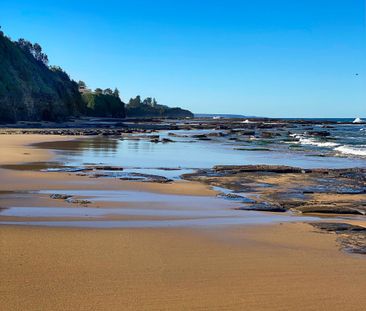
0,190,316,228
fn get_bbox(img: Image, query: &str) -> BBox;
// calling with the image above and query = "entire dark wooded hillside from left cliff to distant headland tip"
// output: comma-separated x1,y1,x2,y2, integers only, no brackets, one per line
0,27,193,122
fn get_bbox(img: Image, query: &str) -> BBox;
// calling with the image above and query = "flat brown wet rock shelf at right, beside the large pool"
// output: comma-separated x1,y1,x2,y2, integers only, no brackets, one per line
183,165,366,215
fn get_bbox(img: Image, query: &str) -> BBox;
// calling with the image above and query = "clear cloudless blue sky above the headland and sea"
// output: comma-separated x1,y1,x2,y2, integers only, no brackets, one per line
0,0,366,117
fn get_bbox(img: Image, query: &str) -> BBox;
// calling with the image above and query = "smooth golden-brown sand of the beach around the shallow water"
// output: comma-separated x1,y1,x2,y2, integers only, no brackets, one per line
0,135,366,310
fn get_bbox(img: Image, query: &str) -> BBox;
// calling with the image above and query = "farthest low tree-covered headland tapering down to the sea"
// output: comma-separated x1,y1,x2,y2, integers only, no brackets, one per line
126,96,193,118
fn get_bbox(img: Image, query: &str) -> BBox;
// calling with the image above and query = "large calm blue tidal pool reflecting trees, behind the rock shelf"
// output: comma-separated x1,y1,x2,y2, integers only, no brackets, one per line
38,131,366,174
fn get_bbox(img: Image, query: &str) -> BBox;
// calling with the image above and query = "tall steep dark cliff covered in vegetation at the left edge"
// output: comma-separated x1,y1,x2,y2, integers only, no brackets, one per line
0,34,85,122
